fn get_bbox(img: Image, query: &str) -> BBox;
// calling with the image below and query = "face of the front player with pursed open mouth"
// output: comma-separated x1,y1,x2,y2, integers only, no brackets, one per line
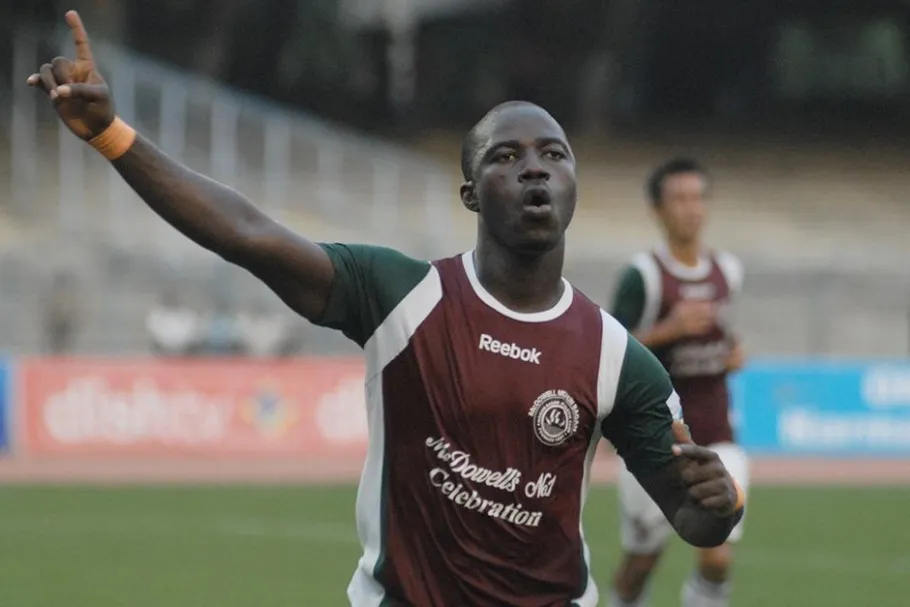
466,106,576,254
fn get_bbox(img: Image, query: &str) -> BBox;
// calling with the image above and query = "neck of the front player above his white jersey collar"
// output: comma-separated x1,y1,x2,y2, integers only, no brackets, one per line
474,239,565,313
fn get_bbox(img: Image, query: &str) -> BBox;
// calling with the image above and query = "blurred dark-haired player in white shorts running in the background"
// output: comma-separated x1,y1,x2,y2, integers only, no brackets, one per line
612,158,748,607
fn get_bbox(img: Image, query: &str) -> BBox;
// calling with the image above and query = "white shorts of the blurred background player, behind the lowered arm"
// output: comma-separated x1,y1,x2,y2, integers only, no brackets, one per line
617,443,749,554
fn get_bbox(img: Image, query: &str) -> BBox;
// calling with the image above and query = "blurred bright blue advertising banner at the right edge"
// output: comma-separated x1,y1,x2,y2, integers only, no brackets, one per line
731,361,910,457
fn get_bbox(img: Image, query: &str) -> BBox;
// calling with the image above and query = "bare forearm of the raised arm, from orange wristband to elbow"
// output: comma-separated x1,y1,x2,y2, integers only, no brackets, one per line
112,135,267,261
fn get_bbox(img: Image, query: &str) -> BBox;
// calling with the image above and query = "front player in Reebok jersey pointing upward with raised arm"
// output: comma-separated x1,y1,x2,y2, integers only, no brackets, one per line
29,12,743,607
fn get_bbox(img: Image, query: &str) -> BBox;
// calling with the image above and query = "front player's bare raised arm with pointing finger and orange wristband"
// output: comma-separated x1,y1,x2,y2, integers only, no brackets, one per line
28,11,334,320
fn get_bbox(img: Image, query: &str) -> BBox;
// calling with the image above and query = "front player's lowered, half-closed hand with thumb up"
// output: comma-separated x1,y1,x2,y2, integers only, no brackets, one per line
673,421,738,517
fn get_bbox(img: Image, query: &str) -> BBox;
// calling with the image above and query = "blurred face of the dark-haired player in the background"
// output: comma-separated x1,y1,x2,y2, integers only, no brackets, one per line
657,173,708,242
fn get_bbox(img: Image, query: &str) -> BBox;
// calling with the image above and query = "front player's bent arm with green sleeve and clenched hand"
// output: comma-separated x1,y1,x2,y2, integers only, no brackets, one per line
602,338,743,548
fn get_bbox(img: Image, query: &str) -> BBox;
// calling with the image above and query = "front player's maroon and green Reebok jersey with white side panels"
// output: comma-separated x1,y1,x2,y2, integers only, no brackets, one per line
319,244,679,607
